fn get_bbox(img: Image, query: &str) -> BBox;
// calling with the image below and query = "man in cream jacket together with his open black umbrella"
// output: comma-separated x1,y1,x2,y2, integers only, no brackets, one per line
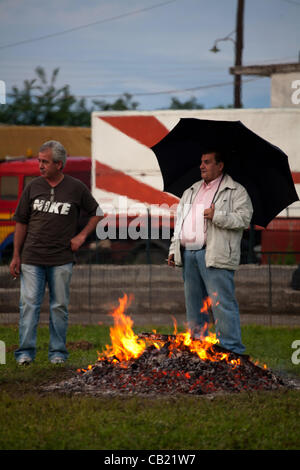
151,118,299,354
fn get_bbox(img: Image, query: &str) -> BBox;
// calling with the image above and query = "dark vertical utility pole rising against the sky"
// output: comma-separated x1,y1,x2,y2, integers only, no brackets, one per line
234,0,245,108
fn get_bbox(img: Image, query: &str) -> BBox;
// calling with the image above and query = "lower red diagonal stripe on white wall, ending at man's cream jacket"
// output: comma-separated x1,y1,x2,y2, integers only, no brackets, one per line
96,161,178,206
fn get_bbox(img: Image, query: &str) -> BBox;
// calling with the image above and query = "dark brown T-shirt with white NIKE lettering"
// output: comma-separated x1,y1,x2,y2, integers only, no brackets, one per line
14,175,98,266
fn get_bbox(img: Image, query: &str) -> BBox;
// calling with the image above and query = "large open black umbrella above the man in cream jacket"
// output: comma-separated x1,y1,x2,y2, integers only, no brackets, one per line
151,118,299,227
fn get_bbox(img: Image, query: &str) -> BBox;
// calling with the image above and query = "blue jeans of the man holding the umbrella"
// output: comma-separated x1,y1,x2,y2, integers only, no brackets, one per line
183,249,245,354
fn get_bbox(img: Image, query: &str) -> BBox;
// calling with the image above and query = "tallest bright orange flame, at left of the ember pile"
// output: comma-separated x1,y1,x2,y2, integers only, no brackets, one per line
98,294,146,362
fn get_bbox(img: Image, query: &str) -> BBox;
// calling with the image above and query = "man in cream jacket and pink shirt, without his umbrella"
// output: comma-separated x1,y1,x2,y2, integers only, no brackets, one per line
168,149,253,354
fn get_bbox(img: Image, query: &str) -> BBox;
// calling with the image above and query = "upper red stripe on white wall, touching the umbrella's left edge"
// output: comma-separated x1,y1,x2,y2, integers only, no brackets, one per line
99,116,169,147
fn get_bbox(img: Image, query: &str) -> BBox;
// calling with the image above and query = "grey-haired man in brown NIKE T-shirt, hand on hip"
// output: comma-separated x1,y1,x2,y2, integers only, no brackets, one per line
10,141,102,364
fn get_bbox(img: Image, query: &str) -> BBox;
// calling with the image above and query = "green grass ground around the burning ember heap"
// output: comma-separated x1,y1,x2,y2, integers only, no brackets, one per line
0,325,300,450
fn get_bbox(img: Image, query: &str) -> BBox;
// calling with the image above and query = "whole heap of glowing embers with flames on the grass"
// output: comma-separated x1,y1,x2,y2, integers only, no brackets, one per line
64,295,283,395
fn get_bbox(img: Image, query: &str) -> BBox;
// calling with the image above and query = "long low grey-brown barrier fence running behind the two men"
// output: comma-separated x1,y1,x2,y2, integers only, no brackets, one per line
0,252,300,326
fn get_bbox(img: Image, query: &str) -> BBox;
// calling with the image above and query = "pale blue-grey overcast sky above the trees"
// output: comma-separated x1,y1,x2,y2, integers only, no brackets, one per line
0,0,300,110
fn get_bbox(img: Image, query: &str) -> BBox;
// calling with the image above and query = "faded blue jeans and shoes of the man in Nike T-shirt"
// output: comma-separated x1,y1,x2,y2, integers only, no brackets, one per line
15,263,73,361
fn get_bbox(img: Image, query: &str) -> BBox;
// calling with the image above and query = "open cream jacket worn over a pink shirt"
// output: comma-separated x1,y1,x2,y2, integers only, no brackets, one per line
169,174,253,270
